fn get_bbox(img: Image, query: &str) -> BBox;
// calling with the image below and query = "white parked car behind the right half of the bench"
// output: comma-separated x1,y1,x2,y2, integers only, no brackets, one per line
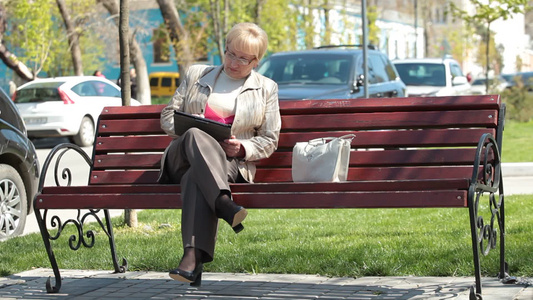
392,57,470,96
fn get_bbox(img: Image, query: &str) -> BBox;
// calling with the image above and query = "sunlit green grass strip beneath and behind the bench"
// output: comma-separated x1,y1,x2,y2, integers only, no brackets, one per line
0,195,533,277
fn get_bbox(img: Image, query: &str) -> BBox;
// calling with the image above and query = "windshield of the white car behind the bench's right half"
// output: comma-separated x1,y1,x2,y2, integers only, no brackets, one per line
395,63,446,86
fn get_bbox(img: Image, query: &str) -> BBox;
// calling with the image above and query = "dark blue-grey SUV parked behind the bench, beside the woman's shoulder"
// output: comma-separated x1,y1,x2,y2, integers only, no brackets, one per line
257,46,405,100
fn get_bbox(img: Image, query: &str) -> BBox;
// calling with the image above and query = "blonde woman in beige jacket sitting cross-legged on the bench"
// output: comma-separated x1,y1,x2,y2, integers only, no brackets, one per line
159,23,281,286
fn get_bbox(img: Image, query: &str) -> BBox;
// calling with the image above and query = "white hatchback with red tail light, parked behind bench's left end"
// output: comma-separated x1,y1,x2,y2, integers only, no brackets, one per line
13,76,140,147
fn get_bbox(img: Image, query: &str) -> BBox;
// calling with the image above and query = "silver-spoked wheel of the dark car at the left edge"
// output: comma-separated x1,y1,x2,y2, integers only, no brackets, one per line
0,164,28,240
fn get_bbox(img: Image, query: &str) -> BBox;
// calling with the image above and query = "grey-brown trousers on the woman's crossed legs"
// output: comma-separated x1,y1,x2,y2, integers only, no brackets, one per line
164,128,243,262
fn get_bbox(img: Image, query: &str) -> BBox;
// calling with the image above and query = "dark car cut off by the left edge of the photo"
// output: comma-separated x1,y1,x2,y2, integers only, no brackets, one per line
0,89,39,240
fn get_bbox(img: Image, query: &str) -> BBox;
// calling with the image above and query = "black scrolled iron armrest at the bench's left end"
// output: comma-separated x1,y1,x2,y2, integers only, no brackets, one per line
38,143,93,194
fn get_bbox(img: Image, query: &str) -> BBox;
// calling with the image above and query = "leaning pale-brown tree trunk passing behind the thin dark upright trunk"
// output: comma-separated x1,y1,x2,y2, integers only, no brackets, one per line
96,0,152,104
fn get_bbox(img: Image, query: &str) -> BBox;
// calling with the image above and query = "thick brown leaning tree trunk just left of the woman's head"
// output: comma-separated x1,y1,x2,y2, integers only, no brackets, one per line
157,0,194,74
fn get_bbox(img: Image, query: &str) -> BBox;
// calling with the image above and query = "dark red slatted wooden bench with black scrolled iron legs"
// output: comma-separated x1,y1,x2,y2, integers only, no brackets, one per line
34,95,513,297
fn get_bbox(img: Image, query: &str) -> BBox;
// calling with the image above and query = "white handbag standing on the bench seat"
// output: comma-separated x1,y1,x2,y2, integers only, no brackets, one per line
292,134,355,182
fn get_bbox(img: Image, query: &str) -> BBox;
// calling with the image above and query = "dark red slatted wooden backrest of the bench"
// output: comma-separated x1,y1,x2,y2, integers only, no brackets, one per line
90,95,501,185
